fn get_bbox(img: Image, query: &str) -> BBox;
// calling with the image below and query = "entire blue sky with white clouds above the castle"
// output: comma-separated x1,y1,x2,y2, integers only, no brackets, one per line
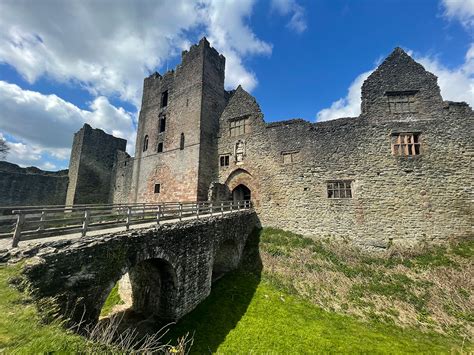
0,0,474,170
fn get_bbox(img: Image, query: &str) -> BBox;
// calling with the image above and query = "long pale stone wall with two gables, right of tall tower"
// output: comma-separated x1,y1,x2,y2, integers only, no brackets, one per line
218,49,473,247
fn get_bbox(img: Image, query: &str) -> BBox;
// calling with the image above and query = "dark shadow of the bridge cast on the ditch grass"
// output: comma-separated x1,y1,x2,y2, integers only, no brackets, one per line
166,229,262,354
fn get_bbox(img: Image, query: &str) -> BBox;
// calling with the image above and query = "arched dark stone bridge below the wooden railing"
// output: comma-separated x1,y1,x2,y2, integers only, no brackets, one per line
8,210,258,324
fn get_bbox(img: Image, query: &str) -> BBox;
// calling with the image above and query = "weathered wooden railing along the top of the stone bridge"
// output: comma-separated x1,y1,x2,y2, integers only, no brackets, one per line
0,201,252,247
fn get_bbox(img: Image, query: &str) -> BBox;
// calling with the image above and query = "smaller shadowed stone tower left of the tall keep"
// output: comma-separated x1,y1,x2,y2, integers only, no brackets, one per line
66,124,127,205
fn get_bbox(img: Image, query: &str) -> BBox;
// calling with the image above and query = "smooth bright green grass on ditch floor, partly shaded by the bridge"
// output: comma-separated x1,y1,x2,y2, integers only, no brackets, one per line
171,271,460,354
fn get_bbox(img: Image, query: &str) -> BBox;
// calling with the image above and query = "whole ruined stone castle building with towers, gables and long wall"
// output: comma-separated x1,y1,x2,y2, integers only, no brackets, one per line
1,38,474,247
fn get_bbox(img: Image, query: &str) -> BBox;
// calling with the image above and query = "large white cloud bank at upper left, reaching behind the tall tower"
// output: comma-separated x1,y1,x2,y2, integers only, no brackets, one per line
0,0,271,107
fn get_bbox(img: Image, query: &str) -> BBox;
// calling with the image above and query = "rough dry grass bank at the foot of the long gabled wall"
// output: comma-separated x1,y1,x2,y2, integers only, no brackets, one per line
260,228,474,341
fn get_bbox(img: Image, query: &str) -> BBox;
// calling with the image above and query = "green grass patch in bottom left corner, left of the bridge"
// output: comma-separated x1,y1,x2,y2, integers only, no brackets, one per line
0,265,104,354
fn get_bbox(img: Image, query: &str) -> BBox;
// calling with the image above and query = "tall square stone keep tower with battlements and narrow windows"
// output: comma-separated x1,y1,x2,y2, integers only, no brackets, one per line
129,38,225,202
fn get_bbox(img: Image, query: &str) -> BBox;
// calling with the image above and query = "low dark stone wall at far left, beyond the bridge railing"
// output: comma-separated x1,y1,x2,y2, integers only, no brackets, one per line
0,161,68,206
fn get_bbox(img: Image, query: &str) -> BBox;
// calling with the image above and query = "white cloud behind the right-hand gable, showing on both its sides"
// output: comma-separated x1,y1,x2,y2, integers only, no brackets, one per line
316,43,474,121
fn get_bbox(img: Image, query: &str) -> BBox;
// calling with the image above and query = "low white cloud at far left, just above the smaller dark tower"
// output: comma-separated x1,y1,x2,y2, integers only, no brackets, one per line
0,81,135,165
